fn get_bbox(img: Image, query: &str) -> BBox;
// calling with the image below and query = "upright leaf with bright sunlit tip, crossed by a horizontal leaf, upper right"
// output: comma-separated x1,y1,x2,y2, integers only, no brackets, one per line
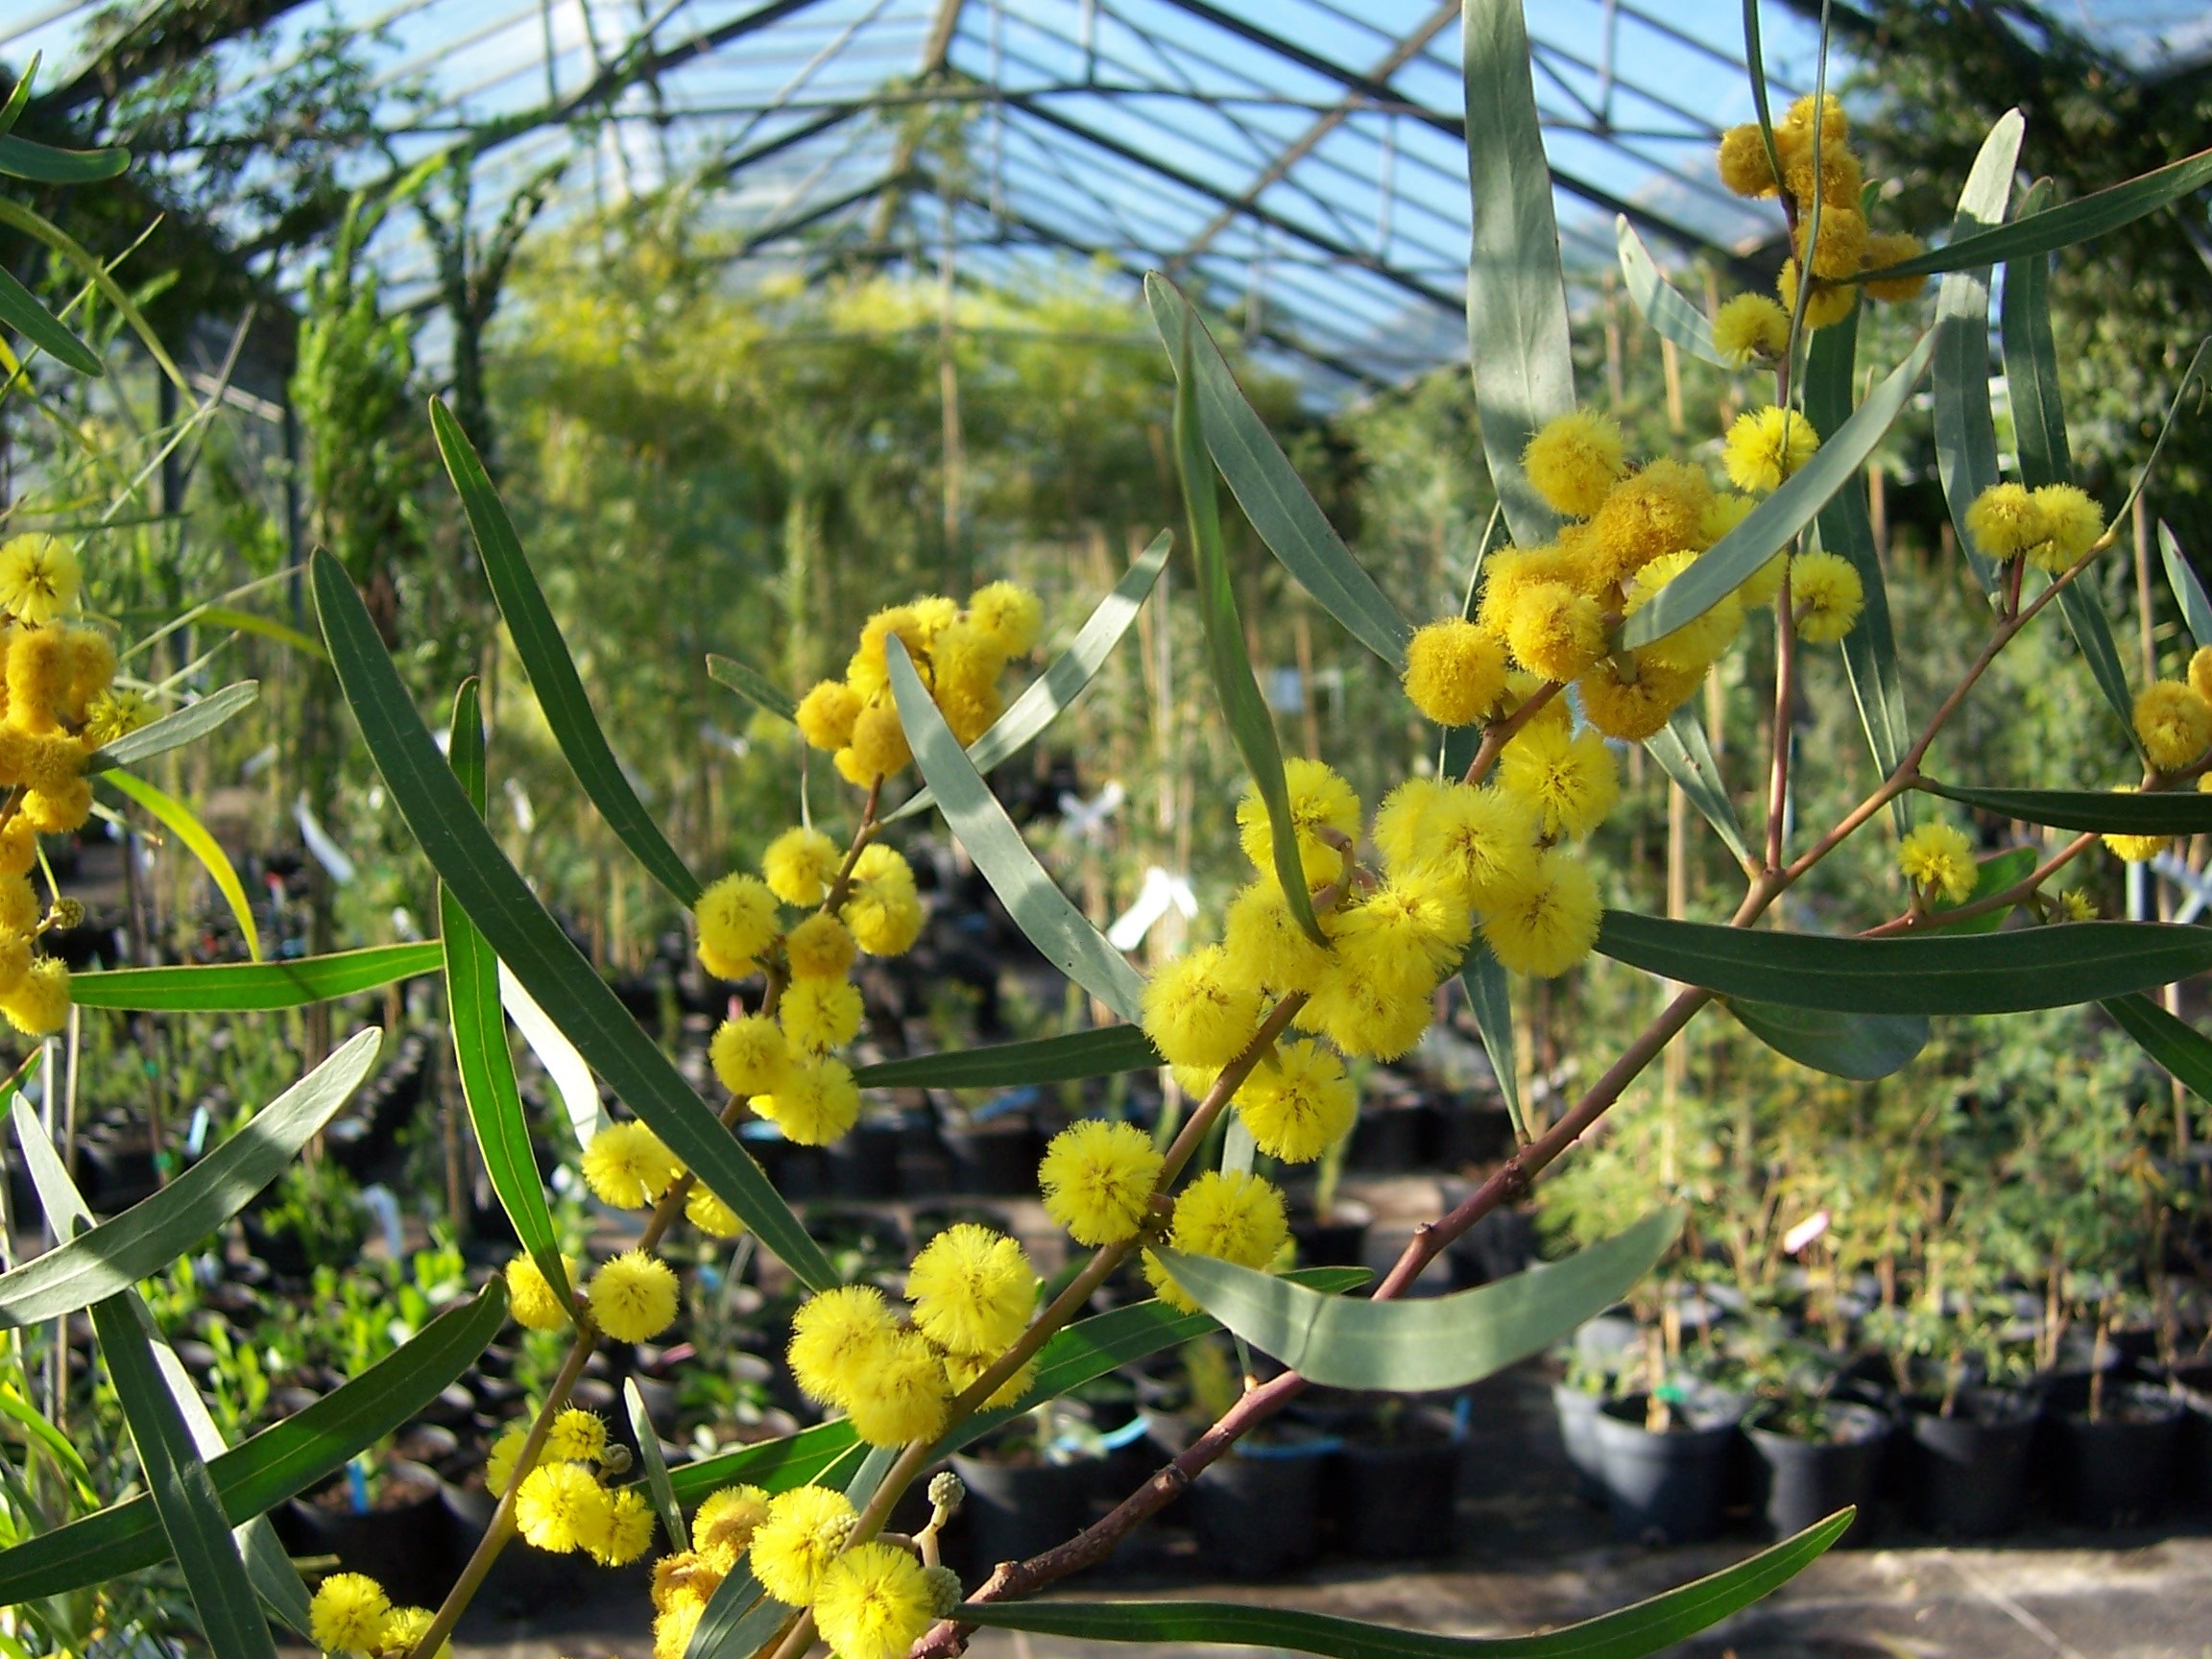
1936,108,2024,592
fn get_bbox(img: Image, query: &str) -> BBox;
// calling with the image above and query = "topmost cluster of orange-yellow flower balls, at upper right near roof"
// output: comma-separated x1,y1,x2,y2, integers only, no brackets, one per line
1712,93,1927,353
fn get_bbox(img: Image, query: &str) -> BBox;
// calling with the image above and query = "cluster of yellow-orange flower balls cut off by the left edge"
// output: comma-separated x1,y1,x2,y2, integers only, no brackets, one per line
0,533,146,1038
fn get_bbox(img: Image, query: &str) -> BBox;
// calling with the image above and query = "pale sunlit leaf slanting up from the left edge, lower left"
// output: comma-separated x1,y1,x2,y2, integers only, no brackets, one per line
0,1028,383,1330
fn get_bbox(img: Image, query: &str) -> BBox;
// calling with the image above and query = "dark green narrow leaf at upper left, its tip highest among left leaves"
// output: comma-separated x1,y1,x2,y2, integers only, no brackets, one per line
429,398,699,907
